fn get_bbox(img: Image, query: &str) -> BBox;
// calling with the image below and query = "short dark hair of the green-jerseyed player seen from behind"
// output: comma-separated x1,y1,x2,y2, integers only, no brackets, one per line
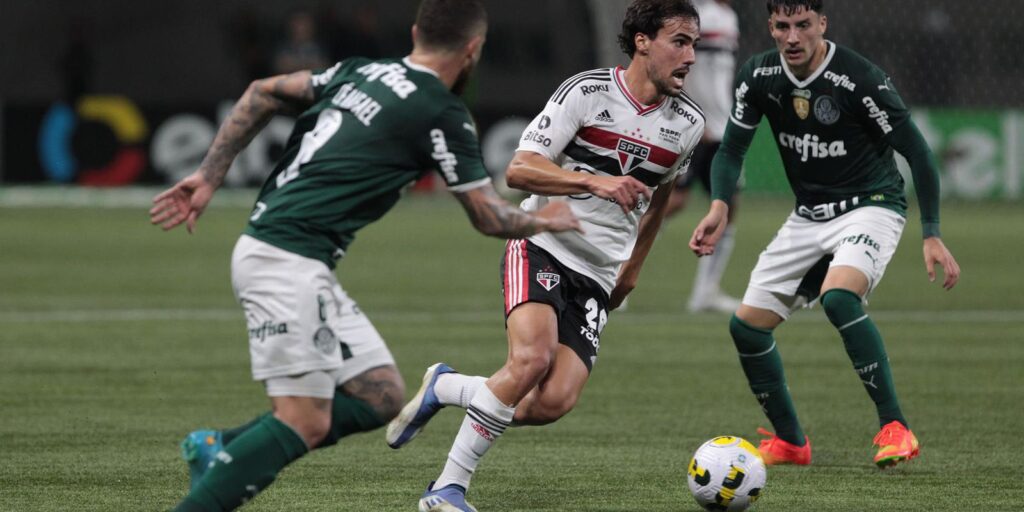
416,0,487,50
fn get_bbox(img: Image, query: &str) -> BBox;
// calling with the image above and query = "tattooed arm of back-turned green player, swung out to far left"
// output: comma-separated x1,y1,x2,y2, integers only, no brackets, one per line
150,71,313,232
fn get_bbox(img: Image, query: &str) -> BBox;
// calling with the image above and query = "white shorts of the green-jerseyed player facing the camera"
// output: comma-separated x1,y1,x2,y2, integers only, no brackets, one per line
742,206,906,319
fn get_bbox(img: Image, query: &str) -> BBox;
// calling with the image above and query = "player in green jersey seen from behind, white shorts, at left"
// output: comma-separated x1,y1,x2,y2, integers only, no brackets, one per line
150,0,579,511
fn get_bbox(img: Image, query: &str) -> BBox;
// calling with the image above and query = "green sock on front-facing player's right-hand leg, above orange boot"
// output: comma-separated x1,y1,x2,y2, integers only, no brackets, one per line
821,289,909,428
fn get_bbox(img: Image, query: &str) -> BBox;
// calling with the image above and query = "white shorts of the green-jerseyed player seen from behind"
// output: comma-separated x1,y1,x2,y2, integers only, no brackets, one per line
231,234,394,398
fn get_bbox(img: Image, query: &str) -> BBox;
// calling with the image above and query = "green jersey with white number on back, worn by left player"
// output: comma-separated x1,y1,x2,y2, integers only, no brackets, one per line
245,57,489,268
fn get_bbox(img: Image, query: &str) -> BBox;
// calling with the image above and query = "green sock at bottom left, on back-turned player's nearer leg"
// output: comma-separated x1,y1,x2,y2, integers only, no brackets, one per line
174,415,308,512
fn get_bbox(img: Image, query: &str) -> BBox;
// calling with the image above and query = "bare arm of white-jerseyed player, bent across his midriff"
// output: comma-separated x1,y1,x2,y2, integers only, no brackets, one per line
505,152,650,213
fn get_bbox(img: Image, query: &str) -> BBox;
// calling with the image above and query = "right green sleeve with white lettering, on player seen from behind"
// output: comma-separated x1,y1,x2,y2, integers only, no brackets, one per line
420,104,490,193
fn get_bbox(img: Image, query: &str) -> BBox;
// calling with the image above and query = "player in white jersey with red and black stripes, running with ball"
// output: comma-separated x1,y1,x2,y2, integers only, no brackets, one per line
388,0,705,511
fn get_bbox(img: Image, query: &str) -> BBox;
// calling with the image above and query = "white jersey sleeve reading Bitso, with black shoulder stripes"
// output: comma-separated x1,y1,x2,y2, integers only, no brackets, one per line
516,79,584,161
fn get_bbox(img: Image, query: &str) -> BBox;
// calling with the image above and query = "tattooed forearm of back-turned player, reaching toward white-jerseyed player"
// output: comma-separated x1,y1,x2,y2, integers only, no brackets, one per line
454,183,583,239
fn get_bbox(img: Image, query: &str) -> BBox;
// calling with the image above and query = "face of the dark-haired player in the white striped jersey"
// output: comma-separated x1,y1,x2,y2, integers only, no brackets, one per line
637,17,700,96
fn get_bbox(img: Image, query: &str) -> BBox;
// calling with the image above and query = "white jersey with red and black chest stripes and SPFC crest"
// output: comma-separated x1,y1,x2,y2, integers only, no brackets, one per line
518,68,705,293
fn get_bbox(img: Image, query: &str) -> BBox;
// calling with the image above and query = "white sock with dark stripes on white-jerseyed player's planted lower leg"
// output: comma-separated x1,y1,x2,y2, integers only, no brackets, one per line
434,385,515,488
